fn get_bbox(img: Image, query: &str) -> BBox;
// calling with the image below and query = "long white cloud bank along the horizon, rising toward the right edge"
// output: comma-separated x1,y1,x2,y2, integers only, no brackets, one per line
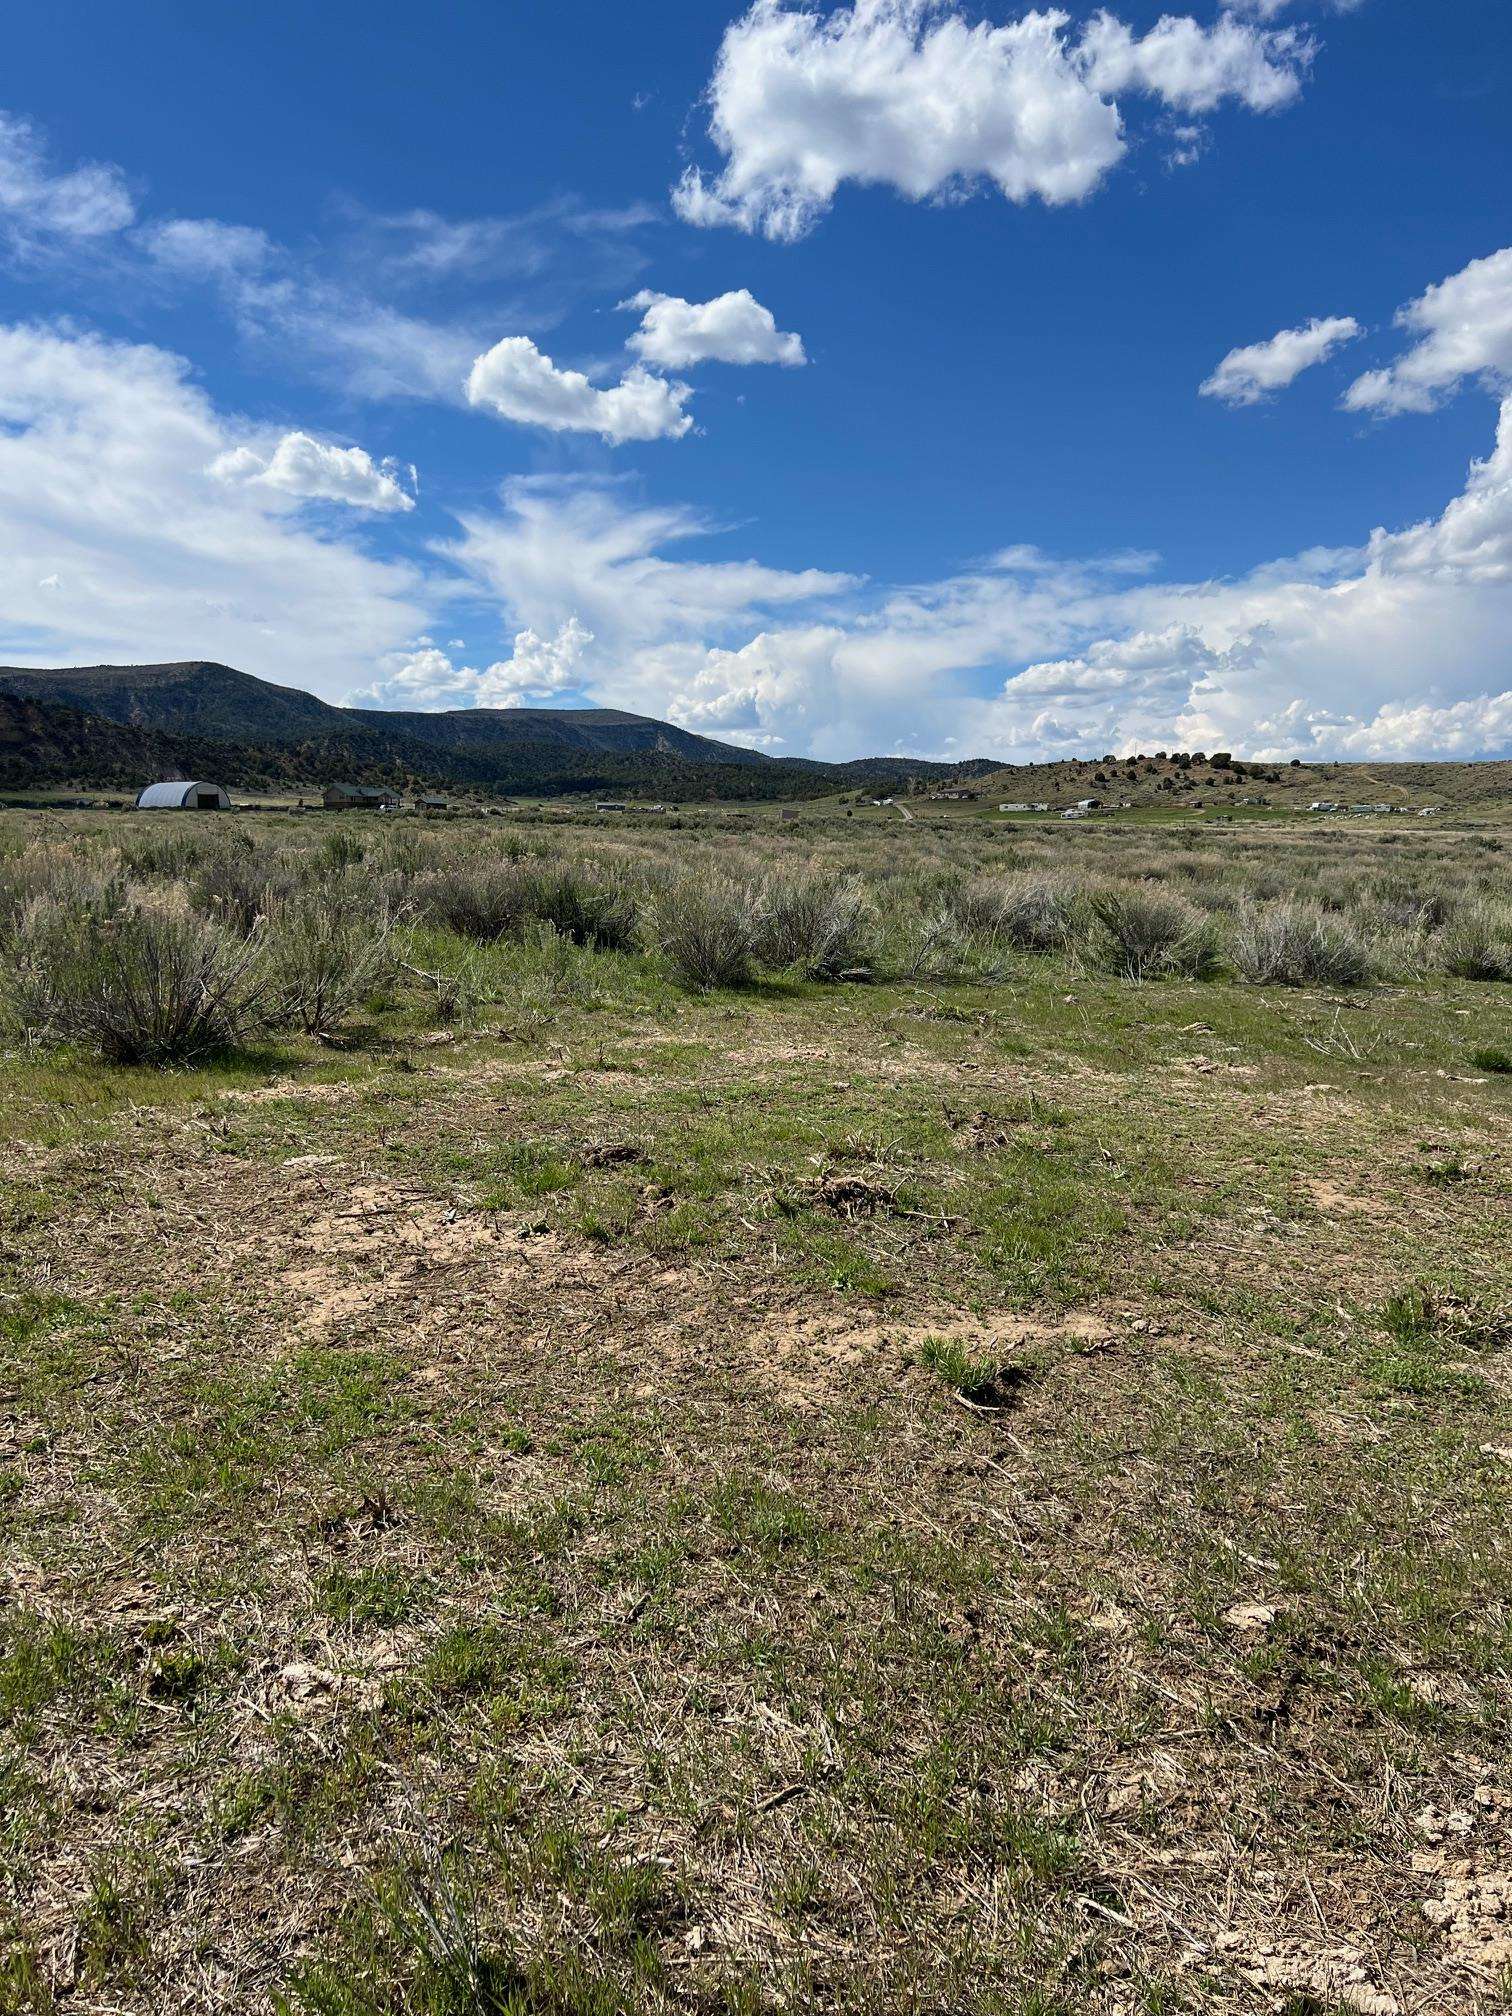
423,399,1512,760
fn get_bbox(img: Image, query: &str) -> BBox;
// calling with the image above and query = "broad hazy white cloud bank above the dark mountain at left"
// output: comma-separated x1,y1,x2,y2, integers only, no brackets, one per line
0,325,429,694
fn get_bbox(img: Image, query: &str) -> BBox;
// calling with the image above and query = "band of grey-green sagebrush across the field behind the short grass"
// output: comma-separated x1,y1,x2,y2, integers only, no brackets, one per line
0,821,1512,1062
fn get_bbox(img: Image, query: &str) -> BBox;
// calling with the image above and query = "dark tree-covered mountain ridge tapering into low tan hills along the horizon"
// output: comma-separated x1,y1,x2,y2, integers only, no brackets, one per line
0,659,1512,808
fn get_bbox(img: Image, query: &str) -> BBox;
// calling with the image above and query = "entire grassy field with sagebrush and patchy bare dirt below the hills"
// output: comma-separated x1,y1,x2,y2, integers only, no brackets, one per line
0,810,1512,2016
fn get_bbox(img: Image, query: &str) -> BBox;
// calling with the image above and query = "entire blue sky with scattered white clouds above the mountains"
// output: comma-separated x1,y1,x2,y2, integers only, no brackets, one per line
0,0,1512,758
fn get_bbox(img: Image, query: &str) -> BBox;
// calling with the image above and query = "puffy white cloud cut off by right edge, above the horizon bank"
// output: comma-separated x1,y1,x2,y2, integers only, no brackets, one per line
1345,246,1512,413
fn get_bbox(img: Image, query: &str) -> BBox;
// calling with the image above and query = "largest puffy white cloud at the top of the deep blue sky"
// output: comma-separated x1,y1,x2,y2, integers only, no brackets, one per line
673,0,1312,240
